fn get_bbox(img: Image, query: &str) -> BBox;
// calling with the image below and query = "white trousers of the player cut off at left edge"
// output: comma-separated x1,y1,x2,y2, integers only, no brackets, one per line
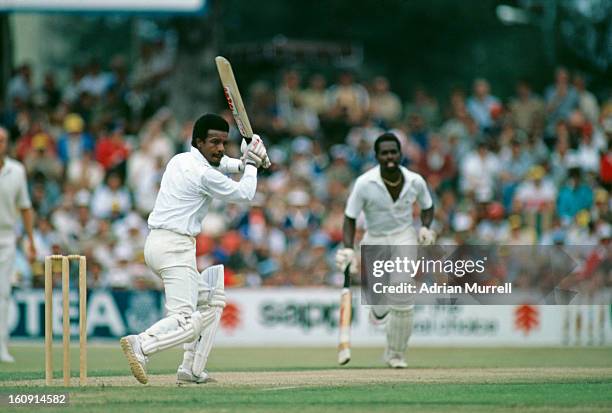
0,234,16,352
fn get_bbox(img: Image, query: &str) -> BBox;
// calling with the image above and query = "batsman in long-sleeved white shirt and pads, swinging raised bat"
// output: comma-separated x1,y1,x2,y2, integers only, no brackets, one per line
120,114,267,383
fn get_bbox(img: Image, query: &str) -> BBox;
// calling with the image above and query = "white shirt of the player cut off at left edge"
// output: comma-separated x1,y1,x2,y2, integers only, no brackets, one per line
0,157,32,238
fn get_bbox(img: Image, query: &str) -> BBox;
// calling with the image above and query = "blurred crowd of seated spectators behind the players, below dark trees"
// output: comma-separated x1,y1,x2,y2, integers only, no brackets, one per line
0,53,612,289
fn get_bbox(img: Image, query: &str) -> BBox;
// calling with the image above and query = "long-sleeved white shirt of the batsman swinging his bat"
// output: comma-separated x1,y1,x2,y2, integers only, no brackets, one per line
148,148,257,237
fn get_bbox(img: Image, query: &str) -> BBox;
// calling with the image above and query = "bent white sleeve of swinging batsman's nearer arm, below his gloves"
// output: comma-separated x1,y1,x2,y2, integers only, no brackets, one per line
202,165,257,202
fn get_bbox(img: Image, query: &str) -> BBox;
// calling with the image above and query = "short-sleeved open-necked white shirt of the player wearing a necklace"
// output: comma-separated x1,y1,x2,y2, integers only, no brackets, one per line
344,166,433,236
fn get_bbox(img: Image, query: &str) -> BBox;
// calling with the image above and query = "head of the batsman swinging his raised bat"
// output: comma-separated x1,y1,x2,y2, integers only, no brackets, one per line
191,113,229,166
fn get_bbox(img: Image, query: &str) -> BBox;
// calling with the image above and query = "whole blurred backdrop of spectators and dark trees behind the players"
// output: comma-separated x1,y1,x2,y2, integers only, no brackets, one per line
0,0,612,289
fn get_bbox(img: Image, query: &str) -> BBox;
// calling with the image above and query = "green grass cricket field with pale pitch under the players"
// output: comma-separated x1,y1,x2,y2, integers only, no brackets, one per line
0,343,612,413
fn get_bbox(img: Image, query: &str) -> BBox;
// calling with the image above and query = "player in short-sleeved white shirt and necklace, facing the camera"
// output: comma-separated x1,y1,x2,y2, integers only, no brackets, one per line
336,133,435,368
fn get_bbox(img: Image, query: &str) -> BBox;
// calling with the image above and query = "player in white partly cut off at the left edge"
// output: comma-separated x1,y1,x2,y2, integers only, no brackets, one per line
0,126,36,363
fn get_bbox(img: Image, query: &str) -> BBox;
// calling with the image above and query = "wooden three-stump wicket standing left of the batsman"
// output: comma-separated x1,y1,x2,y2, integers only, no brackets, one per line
45,255,87,386
